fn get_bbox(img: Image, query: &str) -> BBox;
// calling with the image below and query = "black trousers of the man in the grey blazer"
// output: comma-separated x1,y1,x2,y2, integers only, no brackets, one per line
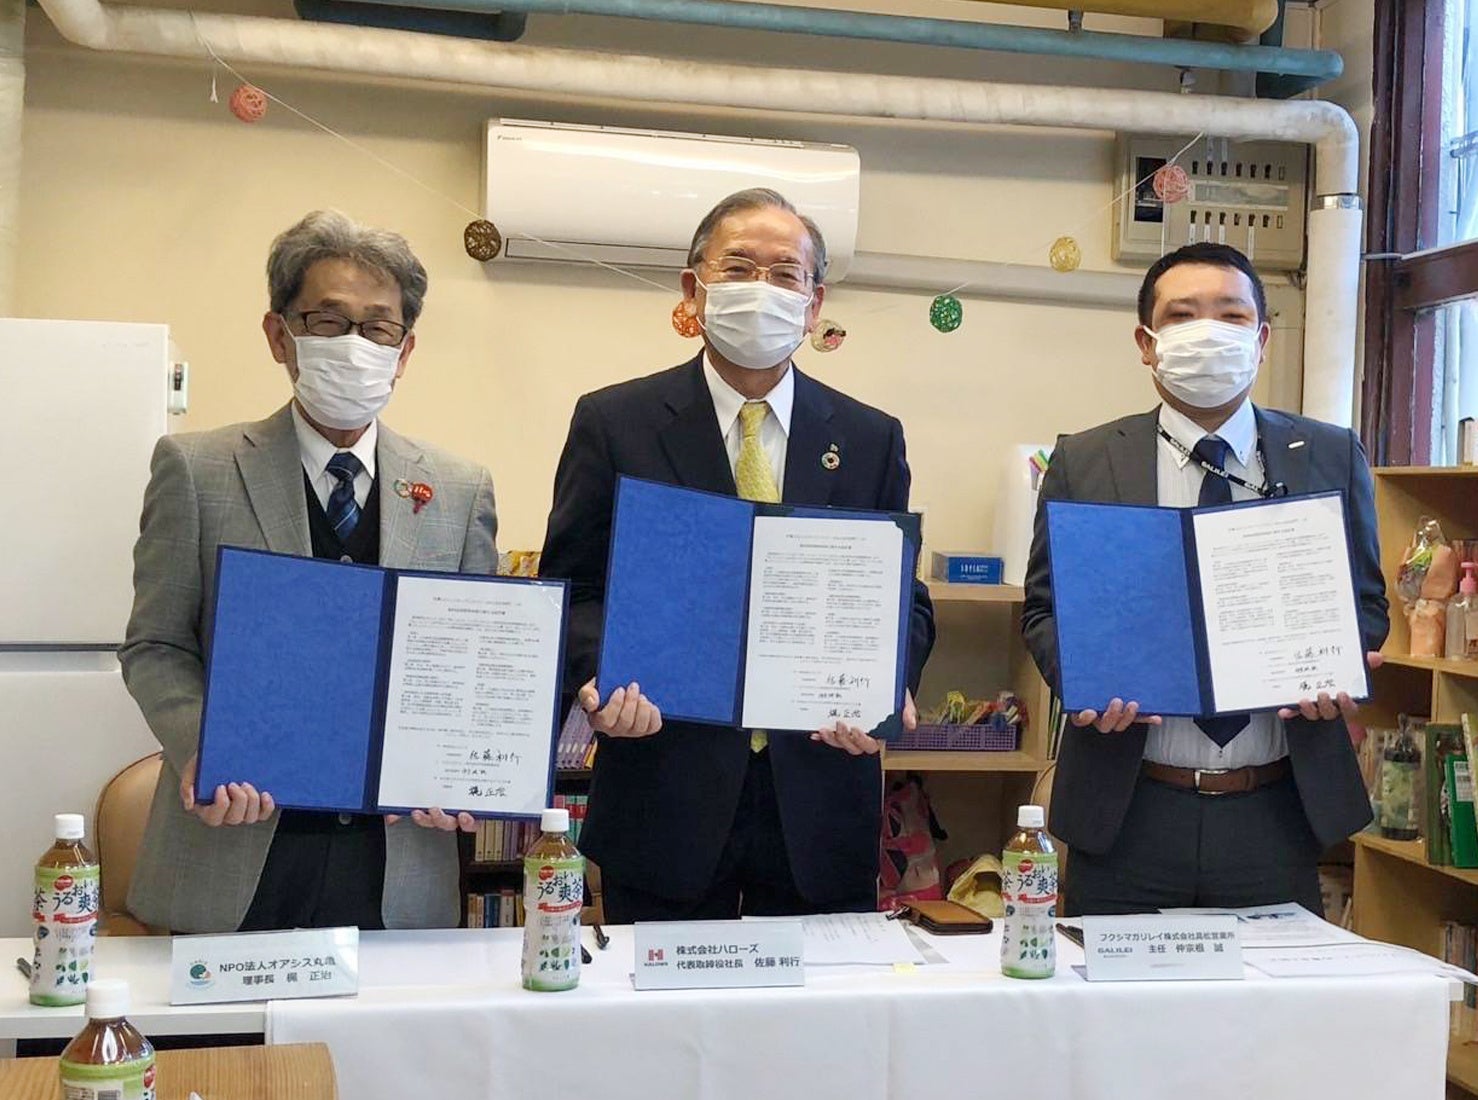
238,810,384,931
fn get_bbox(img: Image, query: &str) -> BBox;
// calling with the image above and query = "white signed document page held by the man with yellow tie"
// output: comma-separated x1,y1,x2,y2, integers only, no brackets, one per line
739,516,903,730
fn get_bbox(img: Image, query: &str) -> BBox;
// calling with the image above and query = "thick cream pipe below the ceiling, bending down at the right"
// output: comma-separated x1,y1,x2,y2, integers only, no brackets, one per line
40,0,1360,424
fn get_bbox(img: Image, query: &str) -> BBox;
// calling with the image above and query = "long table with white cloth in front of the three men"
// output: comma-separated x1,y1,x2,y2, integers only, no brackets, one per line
0,928,1448,1100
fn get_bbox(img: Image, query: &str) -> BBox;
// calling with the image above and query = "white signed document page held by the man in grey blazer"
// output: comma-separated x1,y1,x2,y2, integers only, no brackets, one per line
378,575,562,815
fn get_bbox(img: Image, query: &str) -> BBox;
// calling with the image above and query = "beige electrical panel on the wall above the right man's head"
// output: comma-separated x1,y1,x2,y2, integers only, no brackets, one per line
1113,135,1310,271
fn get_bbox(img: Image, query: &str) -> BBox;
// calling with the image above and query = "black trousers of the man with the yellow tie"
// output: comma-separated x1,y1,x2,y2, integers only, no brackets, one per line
602,750,878,924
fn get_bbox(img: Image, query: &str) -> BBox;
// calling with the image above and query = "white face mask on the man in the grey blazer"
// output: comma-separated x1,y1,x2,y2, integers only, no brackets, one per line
290,333,403,432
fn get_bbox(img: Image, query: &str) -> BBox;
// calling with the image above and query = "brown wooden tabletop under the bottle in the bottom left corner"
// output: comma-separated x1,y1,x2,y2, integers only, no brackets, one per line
0,1042,338,1100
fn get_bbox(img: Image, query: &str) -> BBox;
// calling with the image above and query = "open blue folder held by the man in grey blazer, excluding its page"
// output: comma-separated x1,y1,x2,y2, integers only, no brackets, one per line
195,546,568,816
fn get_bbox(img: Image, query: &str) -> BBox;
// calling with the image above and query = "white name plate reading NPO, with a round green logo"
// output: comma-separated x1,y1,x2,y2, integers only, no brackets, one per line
170,927,359,1004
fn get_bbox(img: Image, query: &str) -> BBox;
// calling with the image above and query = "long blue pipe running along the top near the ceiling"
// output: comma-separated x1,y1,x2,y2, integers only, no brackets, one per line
351,0,1345,95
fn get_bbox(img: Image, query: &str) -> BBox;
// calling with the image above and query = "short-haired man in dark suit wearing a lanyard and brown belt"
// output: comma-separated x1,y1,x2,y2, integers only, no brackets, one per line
1021,244,1388,915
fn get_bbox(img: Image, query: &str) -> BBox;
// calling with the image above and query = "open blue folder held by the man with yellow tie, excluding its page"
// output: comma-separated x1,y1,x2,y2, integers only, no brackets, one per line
596,476,919,738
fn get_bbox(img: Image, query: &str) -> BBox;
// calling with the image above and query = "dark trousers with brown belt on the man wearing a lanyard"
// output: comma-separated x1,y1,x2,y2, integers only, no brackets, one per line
1063,776,1323,917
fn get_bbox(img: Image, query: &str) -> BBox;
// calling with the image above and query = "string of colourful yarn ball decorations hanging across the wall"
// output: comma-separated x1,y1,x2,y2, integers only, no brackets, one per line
191,31,1205,352
